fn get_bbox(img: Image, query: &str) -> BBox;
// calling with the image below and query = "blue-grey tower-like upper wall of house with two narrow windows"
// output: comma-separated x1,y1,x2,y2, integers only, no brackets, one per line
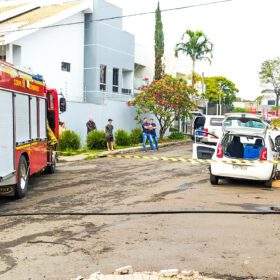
84,0,135,104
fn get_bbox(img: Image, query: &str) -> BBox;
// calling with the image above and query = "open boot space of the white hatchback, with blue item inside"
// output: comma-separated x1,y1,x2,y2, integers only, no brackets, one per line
222,134,265,159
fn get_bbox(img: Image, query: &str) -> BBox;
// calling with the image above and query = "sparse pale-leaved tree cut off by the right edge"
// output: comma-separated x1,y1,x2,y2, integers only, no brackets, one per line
259,57,280,116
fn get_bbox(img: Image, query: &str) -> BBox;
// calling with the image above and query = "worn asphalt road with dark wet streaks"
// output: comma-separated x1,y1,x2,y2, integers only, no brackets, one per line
0,143,280,280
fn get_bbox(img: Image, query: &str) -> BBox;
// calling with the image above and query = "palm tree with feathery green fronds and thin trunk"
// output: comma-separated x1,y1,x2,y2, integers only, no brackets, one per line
175,30,213,86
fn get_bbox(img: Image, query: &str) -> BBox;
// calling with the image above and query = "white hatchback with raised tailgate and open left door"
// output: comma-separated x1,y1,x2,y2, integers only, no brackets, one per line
193,113,279,187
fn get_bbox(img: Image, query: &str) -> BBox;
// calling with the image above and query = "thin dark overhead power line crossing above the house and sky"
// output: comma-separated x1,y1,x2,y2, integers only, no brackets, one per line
0,0,233,36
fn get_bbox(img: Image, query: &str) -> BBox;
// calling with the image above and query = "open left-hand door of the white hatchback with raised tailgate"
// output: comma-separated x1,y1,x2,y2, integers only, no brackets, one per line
192,130,217,159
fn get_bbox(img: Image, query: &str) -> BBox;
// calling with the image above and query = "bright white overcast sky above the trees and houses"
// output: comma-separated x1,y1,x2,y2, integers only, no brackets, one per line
107,0,280,100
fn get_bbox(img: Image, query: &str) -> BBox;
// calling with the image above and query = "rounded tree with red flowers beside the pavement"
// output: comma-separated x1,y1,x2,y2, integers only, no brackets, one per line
128,75,195,138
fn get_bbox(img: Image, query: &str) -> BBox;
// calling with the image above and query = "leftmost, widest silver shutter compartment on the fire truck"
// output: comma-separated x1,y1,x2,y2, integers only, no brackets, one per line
0,90,15,177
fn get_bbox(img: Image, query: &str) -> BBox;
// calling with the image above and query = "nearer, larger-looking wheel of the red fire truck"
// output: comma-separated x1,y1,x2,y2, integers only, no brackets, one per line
15,156,29,198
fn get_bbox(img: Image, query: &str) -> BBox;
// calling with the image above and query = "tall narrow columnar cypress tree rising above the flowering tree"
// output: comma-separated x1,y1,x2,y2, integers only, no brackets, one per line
155,2,164,80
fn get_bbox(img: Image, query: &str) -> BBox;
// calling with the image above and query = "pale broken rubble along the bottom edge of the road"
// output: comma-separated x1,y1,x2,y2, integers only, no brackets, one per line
71,265,223,280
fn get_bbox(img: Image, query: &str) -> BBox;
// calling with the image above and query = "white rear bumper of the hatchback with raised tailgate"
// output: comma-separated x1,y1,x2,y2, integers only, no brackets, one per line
211,162,276,181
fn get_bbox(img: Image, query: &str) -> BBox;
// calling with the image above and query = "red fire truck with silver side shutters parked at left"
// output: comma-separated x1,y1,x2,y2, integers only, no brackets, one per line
0,61,63,198
